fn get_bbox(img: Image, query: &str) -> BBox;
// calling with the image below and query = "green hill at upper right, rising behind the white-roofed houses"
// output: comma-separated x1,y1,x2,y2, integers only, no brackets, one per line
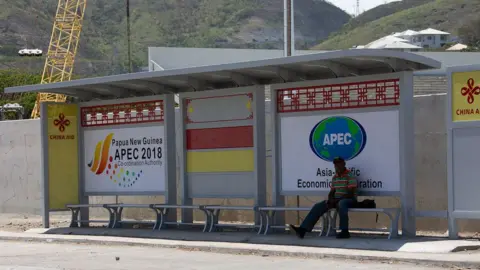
313,0,480,50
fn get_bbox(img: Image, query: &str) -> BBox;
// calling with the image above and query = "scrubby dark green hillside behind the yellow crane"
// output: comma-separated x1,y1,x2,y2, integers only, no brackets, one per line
0,0,350,76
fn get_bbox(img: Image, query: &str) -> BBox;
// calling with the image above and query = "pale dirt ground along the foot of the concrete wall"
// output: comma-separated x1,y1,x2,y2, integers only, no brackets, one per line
0,213,480,239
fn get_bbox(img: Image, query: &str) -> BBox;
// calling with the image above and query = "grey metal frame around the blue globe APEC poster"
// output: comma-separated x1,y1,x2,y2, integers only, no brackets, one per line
270,72,416,236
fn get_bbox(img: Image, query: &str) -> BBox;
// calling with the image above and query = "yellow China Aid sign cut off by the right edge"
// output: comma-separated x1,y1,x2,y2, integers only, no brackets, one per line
452,71,480,122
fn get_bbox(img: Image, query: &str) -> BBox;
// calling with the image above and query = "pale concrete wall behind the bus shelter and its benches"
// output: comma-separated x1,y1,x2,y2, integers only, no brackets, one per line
0,90,480,231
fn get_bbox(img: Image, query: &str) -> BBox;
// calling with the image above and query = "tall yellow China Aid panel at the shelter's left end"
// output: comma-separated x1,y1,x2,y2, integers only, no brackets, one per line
47,104,79,210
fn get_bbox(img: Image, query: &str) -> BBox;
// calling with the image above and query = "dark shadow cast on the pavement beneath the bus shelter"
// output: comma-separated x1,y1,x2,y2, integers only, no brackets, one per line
37,228,480,253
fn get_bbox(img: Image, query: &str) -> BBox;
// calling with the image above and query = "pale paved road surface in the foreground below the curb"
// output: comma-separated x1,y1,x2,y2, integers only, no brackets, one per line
0,241,446,270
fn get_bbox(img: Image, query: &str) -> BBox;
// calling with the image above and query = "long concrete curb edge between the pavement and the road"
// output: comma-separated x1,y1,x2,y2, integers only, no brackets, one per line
0,236,480,269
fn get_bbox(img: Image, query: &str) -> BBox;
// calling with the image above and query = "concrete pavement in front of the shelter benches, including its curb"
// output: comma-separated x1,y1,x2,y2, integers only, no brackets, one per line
0,228,480,269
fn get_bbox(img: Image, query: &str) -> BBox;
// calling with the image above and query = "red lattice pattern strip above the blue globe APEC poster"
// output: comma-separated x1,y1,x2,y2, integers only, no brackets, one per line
277,79,400,113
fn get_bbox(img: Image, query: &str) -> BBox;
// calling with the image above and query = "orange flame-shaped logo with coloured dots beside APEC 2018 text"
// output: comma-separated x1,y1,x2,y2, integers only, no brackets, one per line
87,133,143,188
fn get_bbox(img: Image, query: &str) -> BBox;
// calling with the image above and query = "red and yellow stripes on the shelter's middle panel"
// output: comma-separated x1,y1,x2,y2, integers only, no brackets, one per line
186,126,255,173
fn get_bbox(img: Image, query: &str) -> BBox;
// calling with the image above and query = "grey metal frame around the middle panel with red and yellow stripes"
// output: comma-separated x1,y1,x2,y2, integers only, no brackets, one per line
177,86,266,223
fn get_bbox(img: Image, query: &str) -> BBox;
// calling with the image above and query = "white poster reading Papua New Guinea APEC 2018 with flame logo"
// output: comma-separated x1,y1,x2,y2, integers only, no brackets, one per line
84,126,166,193
